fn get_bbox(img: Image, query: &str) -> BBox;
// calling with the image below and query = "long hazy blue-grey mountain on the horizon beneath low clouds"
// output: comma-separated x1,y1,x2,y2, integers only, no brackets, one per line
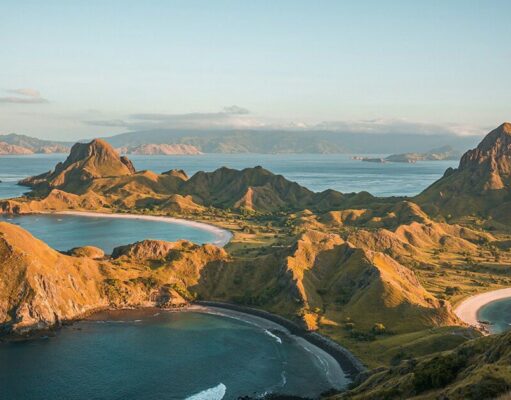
104,129,480,154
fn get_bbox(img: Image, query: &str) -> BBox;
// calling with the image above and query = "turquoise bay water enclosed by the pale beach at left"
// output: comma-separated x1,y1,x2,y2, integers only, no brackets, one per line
0,214,217,254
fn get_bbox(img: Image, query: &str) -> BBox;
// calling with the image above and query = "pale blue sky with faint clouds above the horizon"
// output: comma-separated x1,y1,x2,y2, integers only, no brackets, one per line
0,0,511,140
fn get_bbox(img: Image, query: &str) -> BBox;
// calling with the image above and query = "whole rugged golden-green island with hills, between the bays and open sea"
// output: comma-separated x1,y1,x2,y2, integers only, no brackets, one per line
0,123,511,399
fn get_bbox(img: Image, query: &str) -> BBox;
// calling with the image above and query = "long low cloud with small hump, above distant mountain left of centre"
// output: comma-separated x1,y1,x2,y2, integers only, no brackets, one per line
84,105,265,130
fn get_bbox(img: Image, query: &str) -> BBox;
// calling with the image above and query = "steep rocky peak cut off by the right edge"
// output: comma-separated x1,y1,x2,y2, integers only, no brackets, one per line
415,123,511,224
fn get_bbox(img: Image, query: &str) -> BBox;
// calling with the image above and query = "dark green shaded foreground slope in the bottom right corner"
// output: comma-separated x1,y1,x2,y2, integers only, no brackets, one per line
336,333,511,400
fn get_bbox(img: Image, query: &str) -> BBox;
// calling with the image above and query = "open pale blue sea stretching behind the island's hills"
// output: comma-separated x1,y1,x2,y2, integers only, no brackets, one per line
0,154,458,198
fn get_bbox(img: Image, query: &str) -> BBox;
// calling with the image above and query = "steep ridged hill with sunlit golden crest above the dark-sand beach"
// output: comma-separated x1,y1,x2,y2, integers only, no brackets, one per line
196,231,460,333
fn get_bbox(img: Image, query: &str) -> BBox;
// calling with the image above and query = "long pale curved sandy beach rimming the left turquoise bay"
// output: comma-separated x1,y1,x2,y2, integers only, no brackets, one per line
49,211,232,247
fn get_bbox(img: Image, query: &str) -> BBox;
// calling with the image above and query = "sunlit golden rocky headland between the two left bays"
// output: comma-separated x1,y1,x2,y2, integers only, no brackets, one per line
0,222,227,334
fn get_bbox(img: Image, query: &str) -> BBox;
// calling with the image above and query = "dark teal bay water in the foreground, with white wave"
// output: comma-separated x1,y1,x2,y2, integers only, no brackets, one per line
0,310,346,400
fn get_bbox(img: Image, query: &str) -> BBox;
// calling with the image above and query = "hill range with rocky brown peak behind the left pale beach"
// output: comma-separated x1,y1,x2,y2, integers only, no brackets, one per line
12,139,382,212
